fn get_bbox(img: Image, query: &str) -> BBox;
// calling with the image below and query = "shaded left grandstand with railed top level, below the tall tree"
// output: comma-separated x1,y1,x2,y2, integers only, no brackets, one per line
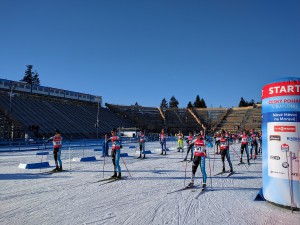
0,79,132,139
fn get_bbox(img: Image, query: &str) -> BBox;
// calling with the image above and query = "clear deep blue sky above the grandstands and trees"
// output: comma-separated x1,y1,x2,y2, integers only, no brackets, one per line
0,0,300,107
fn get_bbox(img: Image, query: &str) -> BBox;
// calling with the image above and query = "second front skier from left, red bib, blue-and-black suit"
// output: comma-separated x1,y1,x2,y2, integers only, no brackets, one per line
106,128,122,178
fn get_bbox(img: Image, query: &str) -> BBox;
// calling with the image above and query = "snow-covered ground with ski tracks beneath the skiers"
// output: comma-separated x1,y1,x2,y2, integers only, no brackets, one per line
0,142,300,225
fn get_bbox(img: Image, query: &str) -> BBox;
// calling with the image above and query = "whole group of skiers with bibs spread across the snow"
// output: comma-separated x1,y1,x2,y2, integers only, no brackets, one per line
47,126,261,188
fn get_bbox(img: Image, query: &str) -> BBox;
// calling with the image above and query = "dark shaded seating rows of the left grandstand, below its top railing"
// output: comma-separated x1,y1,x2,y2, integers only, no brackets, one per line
0,92,132,138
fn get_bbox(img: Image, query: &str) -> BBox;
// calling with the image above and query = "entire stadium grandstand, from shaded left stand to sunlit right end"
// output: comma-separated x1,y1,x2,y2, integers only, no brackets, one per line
0,79,261,142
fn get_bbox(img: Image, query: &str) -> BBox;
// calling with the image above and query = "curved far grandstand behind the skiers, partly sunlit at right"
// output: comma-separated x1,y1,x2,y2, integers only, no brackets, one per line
105,103,261,134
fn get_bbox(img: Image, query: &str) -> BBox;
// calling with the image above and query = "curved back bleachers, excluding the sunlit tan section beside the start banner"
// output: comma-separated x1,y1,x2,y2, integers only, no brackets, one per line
106,104,226,134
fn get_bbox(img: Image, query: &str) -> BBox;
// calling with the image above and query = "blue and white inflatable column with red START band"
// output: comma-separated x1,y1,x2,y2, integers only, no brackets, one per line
262,77,300,208
